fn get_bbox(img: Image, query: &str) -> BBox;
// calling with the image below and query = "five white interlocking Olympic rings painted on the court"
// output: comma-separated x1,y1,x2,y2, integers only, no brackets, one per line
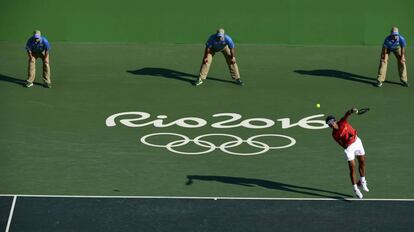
140,133,296,156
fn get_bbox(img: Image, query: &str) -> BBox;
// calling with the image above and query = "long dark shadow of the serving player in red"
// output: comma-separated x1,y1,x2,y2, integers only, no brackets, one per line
186,175,353,200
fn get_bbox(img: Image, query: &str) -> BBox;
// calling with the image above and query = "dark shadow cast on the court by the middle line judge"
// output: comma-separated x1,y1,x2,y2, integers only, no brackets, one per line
127,67,235,84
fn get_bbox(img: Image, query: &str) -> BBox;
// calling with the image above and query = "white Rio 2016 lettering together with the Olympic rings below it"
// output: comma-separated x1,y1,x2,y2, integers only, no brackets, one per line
105,111,328,156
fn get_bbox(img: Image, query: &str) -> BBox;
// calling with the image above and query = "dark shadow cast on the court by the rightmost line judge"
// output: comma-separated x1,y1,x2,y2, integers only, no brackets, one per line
294,69,401,86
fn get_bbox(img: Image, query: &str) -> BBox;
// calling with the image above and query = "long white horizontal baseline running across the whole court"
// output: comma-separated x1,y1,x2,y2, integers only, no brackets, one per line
0,194,414,201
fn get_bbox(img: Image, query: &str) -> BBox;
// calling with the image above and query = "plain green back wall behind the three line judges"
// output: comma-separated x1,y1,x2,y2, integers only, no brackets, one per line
0,0,414,45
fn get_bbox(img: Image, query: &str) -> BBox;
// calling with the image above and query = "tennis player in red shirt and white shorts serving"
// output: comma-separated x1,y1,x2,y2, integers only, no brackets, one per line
326,108,369,199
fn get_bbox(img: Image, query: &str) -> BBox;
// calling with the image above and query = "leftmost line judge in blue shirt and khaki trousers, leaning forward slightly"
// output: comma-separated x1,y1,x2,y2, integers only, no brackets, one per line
26,30,52,88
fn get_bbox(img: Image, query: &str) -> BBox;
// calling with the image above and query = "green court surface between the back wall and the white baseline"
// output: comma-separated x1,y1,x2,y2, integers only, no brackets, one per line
0,43,414,231
